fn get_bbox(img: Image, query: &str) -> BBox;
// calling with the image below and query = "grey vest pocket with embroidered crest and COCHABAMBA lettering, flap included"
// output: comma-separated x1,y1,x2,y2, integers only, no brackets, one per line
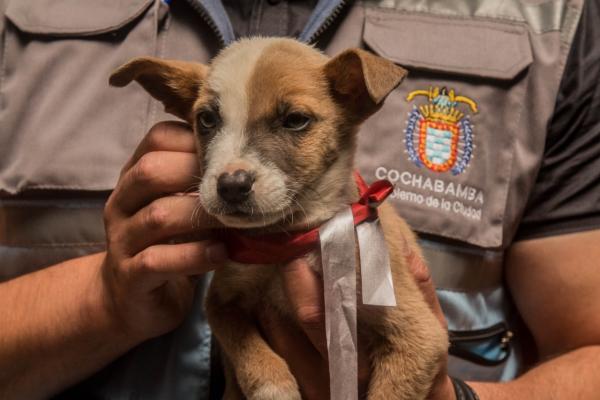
357,7,532,248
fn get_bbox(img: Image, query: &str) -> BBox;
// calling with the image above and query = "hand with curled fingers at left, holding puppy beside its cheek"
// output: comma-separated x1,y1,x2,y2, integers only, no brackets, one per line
102,122,226,341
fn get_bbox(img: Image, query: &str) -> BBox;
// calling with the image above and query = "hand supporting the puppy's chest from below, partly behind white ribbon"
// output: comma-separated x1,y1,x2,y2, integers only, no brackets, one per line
260,254,455,400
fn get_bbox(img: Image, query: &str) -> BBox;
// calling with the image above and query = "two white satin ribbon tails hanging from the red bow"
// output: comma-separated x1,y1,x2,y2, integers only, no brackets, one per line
319,207,396,400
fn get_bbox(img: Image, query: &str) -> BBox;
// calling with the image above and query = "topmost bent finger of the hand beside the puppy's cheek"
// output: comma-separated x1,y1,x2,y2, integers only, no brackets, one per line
121,121,196,175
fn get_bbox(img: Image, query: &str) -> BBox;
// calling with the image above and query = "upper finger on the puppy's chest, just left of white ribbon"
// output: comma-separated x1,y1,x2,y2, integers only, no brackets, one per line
281,259,327,359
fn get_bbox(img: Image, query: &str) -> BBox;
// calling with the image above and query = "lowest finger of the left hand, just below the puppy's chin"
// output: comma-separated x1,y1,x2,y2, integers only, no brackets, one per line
129,241,227,288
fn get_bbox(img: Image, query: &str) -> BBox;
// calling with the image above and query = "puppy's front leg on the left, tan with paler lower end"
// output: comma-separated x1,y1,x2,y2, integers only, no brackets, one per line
206,290,301,400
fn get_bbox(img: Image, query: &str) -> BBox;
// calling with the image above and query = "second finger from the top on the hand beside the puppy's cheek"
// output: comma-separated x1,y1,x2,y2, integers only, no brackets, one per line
111,151,199,215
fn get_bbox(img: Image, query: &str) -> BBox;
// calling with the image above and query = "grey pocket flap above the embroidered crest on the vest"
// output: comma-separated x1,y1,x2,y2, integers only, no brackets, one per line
363,8,533,80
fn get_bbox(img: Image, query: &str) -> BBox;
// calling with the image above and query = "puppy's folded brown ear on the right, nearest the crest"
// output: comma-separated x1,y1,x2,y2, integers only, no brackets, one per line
324,49,407,121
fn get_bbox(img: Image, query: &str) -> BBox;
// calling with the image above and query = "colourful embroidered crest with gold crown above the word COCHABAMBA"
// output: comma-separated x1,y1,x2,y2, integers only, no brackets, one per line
404,87,477,175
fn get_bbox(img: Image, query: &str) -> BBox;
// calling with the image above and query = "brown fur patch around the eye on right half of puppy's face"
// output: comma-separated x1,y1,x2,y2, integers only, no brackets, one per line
248,42,349,209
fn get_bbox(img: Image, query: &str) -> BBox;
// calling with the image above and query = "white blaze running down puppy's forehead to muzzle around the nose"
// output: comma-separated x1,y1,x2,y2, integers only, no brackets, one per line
200,38,290,227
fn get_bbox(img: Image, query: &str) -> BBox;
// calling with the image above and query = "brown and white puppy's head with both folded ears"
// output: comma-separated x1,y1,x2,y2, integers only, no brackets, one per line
110,38,406,227
